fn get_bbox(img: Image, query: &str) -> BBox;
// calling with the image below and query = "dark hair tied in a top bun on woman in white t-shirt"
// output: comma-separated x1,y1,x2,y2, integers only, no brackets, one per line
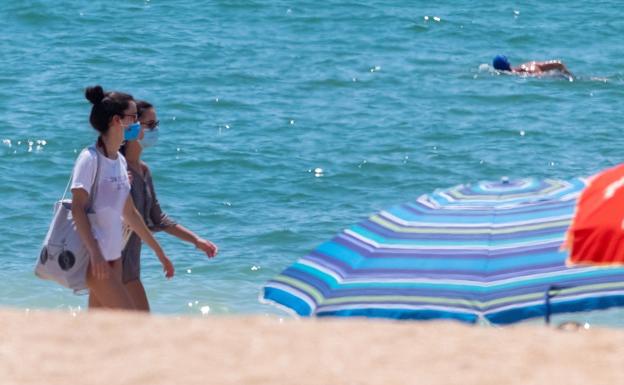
85,85,134,134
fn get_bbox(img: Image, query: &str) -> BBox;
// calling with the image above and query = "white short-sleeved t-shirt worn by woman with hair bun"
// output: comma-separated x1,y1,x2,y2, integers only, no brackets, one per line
71,147,130,261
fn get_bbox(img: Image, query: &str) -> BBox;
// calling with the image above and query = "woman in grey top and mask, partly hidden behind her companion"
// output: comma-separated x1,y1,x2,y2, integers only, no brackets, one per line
120,100,218,311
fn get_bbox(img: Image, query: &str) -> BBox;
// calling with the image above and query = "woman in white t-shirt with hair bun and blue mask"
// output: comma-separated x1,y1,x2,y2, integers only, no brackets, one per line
71,86,174,309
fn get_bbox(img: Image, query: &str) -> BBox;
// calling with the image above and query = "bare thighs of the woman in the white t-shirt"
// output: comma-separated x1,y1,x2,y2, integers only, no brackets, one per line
87,258,135,310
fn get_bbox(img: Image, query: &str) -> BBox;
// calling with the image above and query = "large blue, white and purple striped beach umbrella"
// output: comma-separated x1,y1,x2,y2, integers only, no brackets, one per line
262,179,624,324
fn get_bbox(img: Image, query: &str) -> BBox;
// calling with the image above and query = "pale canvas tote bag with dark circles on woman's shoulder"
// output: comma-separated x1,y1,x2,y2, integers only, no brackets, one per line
35,146,100,293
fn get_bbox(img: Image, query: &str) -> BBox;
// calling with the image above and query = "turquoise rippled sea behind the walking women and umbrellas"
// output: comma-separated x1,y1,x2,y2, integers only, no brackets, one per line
0,0,624,324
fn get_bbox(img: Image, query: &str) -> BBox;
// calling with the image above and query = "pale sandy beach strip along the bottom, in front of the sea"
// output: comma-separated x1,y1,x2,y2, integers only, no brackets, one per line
0,309,624,385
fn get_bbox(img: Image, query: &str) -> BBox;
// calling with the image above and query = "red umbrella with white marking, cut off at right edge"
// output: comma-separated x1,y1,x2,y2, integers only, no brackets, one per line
564,164,624,265
